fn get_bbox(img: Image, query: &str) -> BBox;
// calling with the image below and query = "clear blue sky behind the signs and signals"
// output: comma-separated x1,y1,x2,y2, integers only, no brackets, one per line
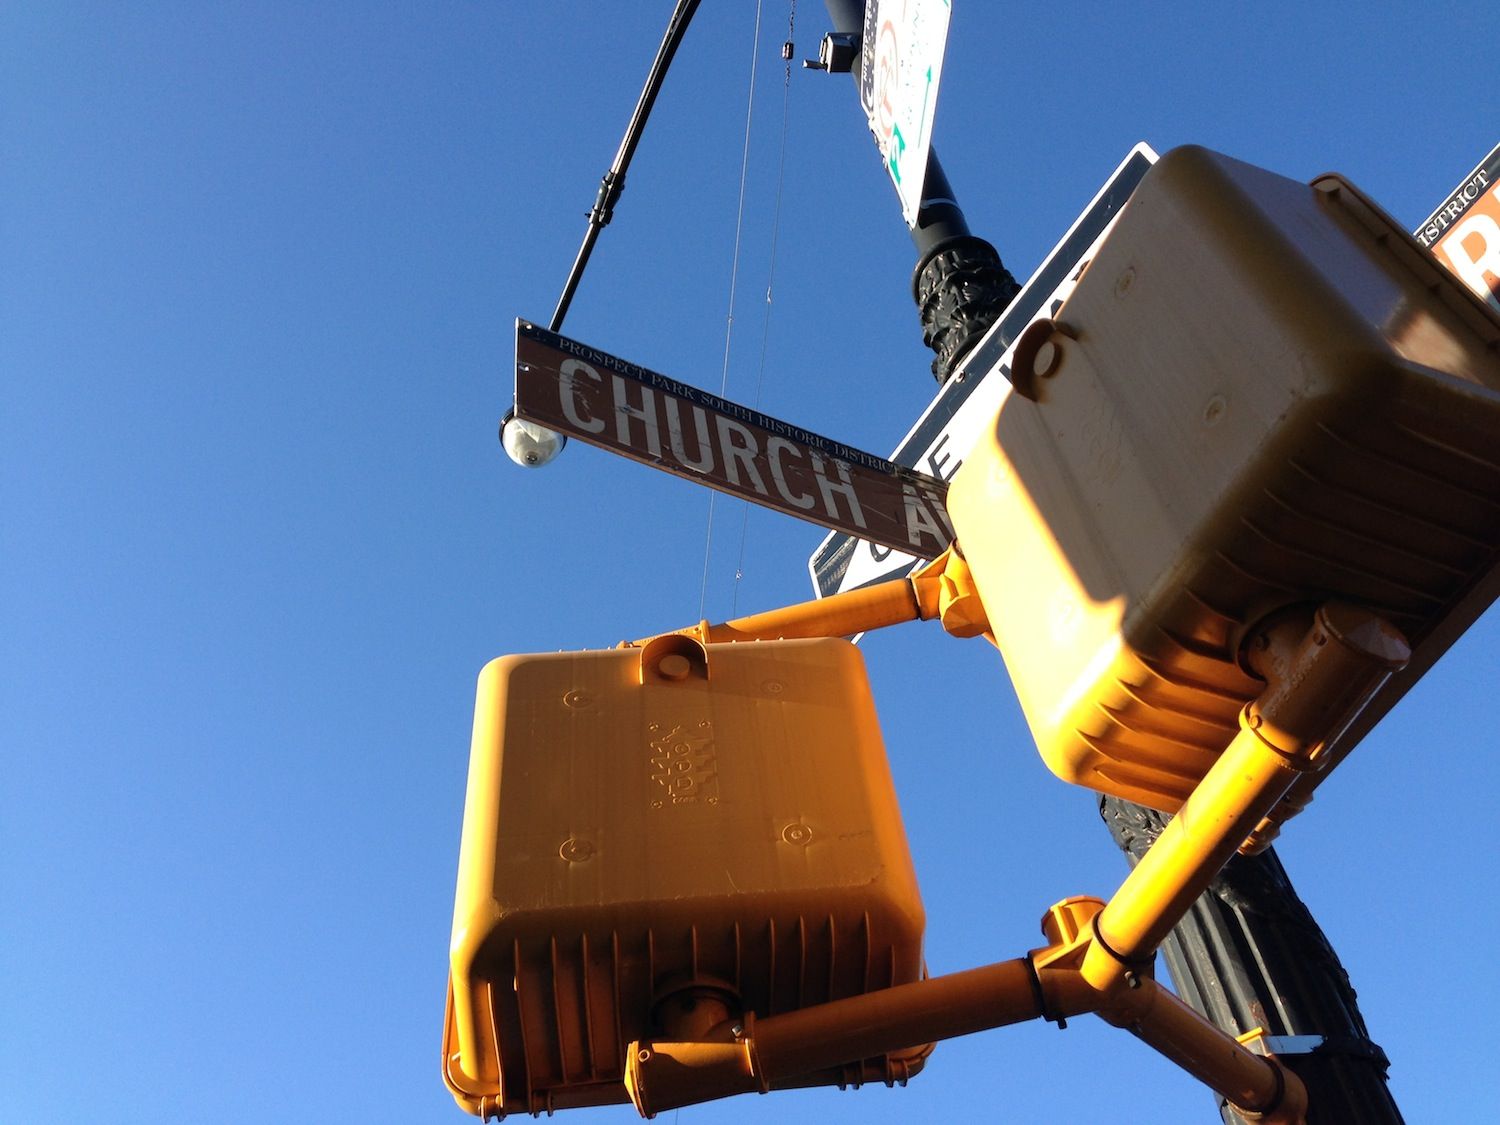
0,0,1500,1125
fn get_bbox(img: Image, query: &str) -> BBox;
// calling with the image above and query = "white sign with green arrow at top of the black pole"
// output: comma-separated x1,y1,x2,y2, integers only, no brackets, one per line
860,0,950,227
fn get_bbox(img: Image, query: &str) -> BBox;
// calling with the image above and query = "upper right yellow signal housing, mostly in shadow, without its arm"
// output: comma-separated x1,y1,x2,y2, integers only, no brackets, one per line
948,149,1500,812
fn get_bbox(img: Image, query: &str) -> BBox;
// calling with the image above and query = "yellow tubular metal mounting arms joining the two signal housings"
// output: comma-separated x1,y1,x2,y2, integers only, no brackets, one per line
626,603,1410,1125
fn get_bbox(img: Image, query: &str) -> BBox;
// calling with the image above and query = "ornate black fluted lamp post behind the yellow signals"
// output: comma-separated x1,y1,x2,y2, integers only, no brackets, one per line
816,0,1403,1125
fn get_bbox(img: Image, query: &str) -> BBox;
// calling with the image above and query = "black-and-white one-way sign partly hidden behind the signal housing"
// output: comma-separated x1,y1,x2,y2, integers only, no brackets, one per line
807,145,1157,597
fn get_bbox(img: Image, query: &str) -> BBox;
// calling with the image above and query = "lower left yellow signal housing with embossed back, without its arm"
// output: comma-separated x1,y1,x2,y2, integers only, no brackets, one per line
444,635,924,1113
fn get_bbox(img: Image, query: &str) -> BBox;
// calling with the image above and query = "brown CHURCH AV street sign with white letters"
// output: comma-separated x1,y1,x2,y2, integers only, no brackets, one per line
516,320,953,558
